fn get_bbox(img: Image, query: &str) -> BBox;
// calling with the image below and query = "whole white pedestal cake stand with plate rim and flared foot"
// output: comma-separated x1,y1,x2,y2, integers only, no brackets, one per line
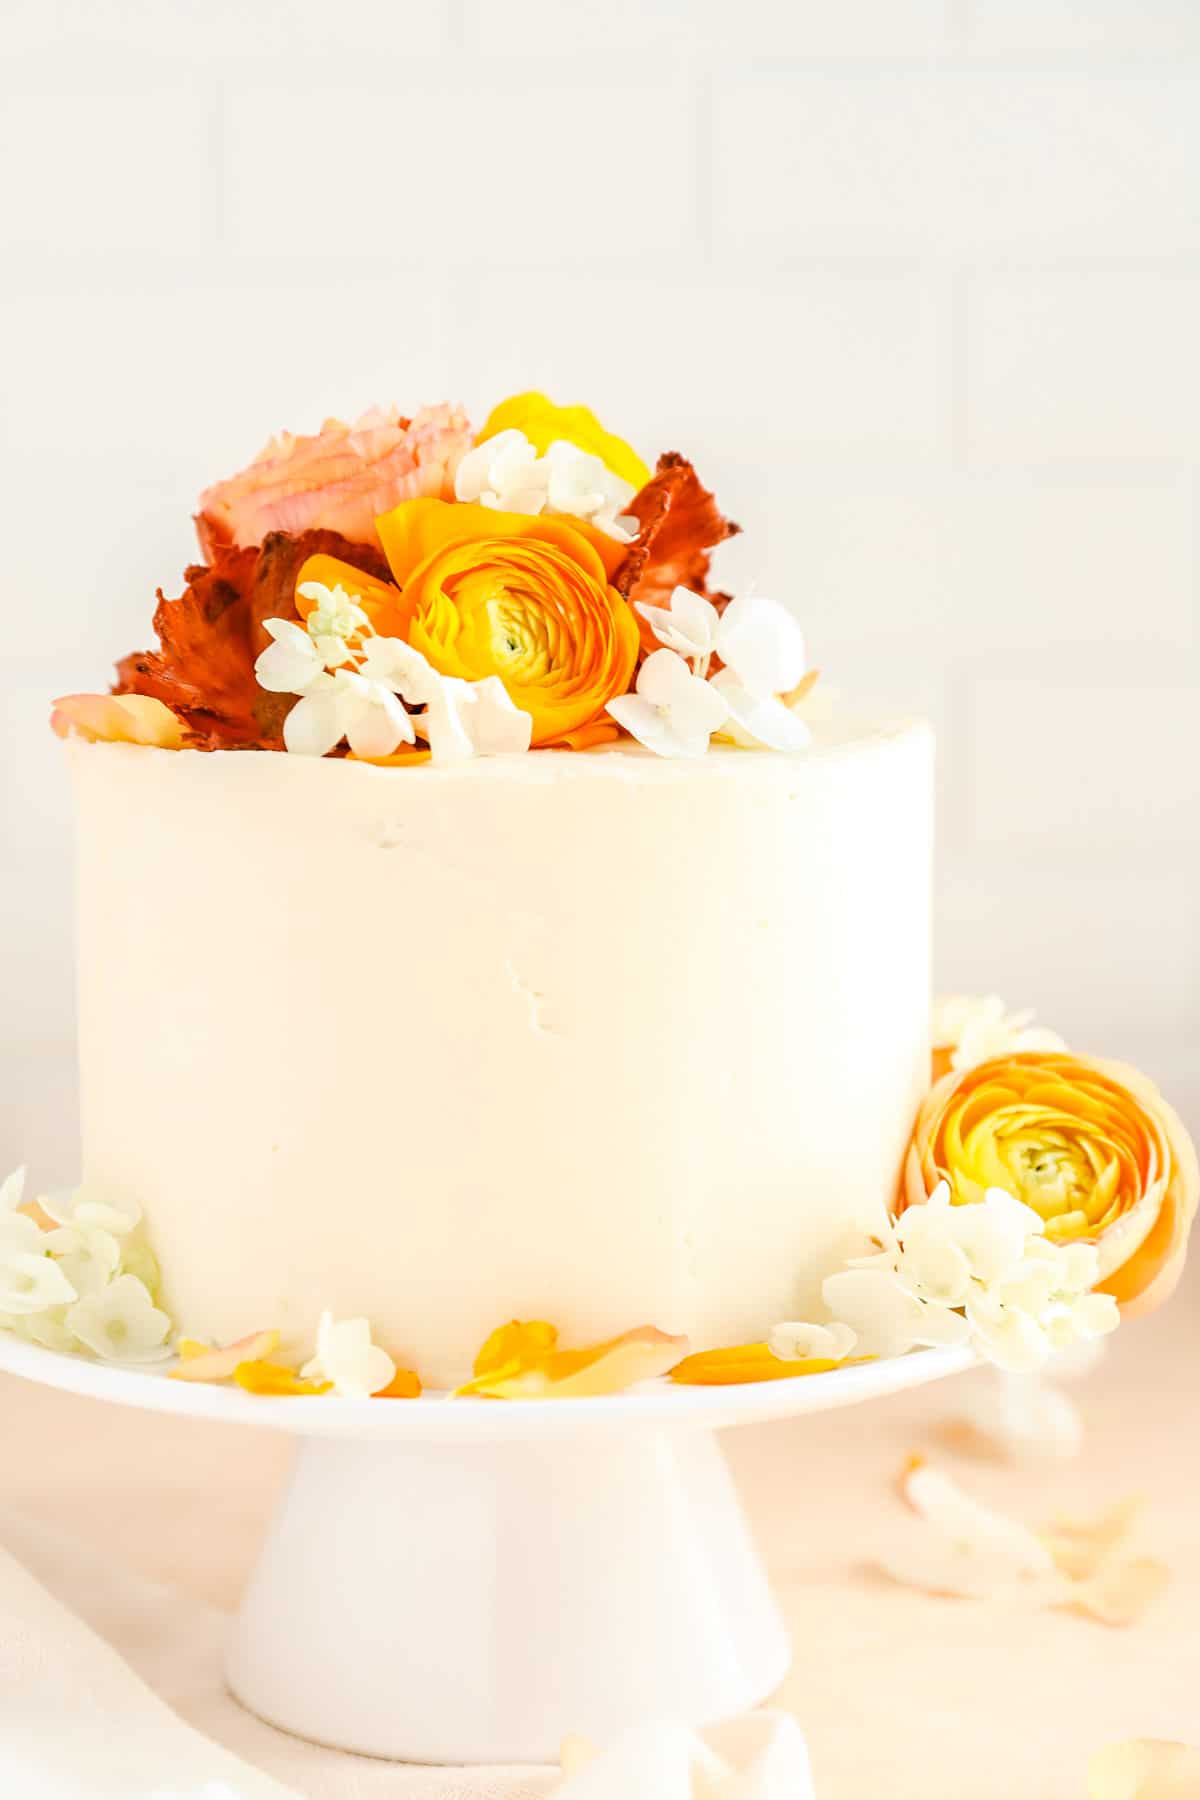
0,1334,972,1762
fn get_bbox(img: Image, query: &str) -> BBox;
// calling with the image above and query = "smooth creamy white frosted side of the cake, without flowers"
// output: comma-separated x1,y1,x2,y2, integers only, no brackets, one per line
68,724,932,1384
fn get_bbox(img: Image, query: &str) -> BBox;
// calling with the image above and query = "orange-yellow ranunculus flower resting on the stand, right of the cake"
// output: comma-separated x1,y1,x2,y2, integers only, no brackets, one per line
898,1051,1200,1312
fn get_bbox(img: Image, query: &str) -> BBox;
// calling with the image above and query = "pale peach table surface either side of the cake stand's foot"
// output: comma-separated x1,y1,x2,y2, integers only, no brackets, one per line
0,1271,1200,1800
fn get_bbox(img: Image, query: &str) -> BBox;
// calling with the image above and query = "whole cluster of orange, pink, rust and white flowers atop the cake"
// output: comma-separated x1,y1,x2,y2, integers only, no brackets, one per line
52,394,813,765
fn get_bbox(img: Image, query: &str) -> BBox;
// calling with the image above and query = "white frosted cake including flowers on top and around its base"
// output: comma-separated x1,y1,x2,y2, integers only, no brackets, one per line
9,394,1200,1397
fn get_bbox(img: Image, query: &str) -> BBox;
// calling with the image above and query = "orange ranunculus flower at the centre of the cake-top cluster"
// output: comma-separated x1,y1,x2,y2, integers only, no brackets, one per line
376,500,639,745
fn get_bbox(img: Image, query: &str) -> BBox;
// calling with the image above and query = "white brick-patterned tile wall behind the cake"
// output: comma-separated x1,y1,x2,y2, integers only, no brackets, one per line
0,0,1200,1175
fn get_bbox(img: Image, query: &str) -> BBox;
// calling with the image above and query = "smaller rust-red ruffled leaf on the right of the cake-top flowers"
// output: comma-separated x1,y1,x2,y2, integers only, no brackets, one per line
613,450,741,633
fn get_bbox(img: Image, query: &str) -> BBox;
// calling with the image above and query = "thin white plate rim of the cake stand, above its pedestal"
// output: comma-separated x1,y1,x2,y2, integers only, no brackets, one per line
0,1330,979,1445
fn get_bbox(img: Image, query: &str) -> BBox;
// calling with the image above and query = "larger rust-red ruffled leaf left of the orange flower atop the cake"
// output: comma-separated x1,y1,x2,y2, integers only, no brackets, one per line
113,531,387,751
